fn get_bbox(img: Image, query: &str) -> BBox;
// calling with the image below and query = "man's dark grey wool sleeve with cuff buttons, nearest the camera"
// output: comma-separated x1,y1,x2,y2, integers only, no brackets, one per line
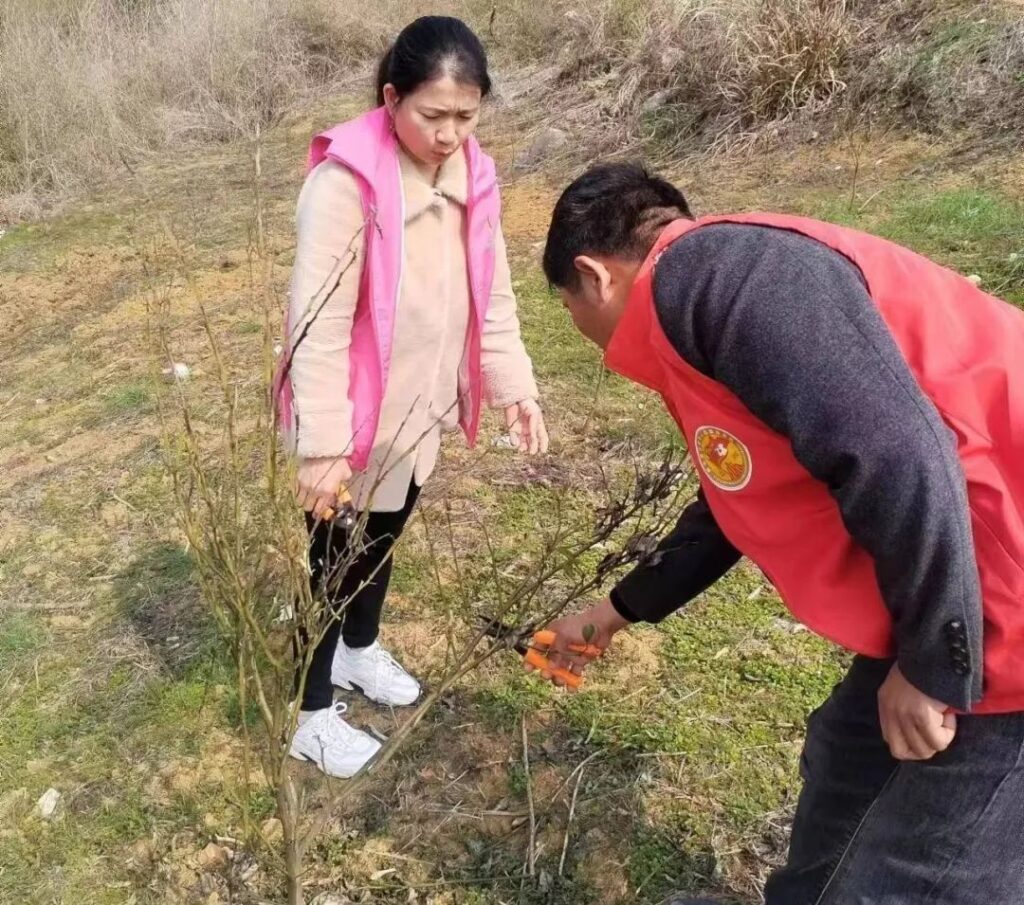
654,224,982,709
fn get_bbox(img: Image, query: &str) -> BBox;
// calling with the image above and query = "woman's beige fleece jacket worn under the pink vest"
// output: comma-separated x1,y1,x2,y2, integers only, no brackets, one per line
289,142,538,512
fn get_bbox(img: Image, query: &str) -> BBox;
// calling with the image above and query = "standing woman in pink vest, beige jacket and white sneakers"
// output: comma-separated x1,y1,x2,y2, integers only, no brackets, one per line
282,16,548,777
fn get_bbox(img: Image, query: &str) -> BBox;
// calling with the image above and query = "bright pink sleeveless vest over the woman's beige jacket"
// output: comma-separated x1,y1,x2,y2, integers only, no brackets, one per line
273,107,501,471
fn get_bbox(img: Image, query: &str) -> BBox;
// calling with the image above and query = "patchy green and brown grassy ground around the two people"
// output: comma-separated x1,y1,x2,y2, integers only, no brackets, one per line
0,92,1024,905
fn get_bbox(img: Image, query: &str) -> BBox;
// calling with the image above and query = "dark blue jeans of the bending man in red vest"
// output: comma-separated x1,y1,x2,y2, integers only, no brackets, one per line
765,657,1024,905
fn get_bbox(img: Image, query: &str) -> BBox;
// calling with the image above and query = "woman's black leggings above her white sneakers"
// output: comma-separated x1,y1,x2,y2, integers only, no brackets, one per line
296,483,420,710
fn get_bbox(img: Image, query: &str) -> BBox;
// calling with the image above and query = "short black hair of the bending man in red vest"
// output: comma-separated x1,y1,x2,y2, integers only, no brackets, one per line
544,164,692,291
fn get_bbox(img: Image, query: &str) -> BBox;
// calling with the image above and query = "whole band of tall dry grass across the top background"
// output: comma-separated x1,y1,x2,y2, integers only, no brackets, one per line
0,0,1024,219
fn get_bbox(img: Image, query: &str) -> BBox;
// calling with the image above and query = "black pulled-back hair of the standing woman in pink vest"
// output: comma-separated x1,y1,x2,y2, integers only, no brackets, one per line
377,15,490,106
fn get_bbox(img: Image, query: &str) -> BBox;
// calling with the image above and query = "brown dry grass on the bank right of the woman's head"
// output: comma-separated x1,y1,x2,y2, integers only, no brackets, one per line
524,0,1024,157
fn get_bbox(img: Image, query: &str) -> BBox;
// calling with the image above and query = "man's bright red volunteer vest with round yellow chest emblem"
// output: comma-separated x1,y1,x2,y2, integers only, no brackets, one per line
605,214,1024,713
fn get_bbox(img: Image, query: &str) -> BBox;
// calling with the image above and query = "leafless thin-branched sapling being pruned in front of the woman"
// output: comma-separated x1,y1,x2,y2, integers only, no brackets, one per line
150,136,690,905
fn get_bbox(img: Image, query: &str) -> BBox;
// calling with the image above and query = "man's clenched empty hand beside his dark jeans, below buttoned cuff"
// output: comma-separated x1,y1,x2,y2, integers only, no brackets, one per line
879,664,956,761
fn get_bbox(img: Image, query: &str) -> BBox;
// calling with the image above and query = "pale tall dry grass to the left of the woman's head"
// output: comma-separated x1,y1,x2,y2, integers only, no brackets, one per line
0,0,368,216
